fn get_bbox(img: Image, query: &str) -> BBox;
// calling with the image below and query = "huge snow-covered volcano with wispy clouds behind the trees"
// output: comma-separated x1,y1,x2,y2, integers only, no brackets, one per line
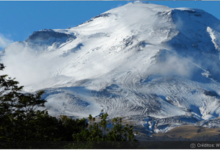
0,3,220,132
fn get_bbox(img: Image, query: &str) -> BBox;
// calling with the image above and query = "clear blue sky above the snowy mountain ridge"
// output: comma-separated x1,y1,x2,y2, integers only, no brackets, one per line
0,1,220,50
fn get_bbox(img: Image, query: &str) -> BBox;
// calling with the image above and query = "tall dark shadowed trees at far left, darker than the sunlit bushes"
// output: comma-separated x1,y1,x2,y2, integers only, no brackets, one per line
0,64,88,148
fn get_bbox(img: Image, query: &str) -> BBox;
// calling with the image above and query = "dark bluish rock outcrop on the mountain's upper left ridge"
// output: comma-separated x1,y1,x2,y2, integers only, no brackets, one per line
26,29,76,42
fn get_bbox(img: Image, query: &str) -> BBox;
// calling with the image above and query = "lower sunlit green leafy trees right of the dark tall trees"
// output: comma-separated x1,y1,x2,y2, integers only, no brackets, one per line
65,113,139,148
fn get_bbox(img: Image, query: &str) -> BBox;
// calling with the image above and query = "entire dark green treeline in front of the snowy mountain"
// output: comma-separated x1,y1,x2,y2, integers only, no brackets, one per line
0,64,138,148
